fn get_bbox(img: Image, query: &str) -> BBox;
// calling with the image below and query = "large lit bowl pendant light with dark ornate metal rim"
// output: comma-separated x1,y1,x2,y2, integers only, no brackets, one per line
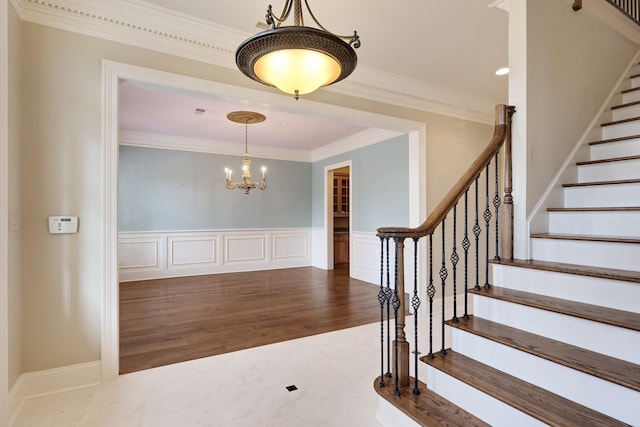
236,0,360,99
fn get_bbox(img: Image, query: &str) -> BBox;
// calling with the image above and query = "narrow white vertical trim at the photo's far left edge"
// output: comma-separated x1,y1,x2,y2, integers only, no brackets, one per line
0,0,10,425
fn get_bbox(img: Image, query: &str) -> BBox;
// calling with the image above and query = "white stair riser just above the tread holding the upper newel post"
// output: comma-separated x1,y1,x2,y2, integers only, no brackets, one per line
531,238,640,271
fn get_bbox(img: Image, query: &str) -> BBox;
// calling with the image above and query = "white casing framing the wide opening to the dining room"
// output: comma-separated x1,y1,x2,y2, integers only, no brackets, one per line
102,60,426,381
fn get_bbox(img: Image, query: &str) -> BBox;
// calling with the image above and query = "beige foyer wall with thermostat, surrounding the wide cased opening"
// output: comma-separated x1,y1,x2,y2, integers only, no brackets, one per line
21,23,492,372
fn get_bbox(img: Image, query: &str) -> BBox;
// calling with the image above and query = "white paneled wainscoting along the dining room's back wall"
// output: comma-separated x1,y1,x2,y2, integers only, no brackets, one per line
118,228,312,282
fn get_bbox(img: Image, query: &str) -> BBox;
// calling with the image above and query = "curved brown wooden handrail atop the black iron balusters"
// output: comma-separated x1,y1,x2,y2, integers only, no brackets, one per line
377,104,515,238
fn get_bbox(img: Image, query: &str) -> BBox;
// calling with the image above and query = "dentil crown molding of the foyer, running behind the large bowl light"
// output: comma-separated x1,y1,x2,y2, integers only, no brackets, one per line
11,0,498,124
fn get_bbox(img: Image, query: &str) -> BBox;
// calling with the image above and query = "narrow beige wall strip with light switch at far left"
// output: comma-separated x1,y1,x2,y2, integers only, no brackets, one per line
7,3,22,387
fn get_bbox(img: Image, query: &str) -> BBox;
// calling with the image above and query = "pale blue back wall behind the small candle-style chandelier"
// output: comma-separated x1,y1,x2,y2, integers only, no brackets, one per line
118,145,311,231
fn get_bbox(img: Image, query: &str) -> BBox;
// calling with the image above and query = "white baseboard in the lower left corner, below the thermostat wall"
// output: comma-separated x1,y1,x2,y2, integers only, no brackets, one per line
7,361,101,425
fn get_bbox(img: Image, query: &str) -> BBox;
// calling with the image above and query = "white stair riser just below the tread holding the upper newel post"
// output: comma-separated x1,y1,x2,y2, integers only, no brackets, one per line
492,264,640,313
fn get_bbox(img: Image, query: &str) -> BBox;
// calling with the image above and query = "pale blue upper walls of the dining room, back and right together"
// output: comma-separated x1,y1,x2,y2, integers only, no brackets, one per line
118,135,409,232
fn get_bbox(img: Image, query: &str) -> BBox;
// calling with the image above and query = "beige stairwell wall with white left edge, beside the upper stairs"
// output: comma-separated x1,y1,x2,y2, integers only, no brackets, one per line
509,0,638,257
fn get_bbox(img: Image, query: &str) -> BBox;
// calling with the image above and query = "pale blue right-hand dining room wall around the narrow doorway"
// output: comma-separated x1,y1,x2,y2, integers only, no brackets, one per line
312,135,409,232
